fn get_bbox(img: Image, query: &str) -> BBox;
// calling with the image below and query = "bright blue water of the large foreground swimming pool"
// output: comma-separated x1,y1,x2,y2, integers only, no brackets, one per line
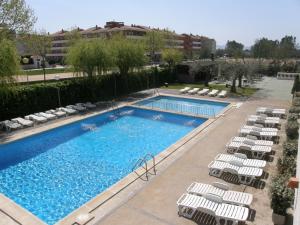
0,107,205,225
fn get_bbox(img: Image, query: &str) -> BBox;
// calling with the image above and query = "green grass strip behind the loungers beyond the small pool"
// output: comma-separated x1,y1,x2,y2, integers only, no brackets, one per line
161,83,257,97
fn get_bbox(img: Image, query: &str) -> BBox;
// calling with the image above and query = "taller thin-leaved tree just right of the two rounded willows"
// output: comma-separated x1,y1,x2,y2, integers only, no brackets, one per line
145,30,165,62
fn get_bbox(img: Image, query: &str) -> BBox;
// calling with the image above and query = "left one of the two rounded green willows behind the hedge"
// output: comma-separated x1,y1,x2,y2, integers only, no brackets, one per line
67,39,113,77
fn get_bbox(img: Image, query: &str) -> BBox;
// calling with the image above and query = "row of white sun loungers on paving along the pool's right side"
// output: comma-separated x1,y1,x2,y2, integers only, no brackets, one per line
177,108,285,225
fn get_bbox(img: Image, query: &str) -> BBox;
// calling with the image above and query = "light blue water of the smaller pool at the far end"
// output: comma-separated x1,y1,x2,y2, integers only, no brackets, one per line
136,96,229,117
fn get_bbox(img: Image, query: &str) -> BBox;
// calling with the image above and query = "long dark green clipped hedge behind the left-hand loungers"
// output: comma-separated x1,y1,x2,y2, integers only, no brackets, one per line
0,69,174,121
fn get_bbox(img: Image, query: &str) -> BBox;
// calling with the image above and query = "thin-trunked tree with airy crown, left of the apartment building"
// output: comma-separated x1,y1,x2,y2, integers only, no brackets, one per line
22,31,51,81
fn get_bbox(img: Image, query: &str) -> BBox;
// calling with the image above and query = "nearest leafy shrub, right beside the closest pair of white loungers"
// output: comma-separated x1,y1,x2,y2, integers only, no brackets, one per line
270,175,294,216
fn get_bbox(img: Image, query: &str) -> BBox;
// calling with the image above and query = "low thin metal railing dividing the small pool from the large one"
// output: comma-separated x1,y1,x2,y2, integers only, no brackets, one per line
144,100,216,117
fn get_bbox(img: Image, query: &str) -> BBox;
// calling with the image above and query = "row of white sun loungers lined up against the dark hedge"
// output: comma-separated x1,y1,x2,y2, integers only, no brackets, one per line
0,102,96,131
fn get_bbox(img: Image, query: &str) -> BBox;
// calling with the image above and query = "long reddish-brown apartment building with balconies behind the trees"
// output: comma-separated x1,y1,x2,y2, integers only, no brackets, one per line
47,21,215,63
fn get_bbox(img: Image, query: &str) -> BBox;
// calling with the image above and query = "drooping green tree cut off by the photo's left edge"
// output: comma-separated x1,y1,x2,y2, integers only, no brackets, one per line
0,39,19,88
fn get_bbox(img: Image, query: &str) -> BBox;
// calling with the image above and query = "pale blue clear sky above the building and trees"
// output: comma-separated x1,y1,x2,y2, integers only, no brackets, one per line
26,0,300,46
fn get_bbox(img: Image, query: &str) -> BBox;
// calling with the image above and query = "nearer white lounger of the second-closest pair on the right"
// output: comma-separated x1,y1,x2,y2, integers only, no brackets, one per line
208,161,263,185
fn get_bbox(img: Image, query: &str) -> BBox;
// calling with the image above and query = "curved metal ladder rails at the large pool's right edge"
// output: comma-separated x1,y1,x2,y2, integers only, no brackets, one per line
132,153,156,181
